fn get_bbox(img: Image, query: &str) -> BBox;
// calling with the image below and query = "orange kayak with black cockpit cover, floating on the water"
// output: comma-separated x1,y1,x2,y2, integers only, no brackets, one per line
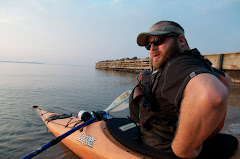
33,106,240,159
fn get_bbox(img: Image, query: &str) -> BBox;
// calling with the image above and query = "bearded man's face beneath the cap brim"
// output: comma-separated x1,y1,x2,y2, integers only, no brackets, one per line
148,36,181,69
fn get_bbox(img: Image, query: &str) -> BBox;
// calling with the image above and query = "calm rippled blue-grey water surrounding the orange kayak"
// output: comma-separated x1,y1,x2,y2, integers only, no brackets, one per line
0,63,240,159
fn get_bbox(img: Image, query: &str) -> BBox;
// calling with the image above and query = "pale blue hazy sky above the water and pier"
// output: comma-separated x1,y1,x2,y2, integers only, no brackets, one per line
0,0,240,66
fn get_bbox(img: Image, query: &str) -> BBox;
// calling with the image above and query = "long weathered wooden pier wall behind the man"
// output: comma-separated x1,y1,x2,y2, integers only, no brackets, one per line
96,52,240,83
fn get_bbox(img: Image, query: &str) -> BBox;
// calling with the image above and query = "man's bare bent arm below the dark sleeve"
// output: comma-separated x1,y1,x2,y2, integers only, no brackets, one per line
172,73,229,158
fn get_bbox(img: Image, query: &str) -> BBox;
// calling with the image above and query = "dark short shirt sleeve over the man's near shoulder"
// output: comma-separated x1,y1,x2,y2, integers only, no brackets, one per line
161,55,212,107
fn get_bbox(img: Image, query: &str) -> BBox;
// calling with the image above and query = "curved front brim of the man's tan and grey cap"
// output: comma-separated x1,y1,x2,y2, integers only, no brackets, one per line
137,31,171,46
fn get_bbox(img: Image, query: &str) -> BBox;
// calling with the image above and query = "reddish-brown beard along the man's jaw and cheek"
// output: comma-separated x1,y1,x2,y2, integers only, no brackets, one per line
150,38,183,69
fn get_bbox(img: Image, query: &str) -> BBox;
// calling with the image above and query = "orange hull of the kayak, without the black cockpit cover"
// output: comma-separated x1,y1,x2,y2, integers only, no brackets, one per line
34,107,148,159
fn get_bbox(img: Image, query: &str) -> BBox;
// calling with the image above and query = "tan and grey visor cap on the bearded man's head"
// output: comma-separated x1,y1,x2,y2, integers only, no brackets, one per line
137,24,184,46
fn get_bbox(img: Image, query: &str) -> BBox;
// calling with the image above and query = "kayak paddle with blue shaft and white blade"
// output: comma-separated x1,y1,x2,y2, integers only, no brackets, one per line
22,90,131,159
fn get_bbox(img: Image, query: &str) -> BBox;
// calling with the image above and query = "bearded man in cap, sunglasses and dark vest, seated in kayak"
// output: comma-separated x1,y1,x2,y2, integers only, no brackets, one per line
130,21,238,158
